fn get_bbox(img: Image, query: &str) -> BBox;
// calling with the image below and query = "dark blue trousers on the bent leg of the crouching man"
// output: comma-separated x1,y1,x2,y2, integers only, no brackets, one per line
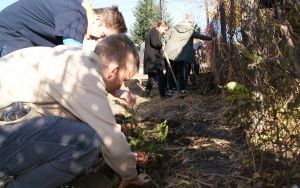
0,116,100,188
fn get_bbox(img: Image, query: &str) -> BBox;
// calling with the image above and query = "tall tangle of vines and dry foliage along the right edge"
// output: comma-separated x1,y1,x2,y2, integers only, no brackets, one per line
211,0,300,186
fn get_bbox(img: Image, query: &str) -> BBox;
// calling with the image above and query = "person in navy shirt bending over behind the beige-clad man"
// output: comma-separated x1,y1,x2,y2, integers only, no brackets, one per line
0,0,127,57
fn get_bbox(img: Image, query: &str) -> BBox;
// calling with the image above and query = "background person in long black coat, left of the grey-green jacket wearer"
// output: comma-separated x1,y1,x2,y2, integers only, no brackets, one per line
144,21,168,98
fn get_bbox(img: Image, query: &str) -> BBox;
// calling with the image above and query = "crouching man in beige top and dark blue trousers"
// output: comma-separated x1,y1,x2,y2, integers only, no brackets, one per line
0,35,147,188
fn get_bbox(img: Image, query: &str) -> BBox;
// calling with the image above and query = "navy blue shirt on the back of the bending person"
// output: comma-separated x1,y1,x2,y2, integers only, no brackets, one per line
0,0,87,55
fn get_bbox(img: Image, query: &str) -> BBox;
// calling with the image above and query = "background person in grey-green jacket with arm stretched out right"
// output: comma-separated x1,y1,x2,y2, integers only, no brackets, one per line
165,14,211,93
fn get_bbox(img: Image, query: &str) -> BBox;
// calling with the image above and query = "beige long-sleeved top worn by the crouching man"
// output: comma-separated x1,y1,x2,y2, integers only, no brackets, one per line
0,46,137,180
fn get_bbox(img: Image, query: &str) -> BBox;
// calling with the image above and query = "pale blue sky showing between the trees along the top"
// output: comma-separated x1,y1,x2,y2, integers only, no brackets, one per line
0,0,206,31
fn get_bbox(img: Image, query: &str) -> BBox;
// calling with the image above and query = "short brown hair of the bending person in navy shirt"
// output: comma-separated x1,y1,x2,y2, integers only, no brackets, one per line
93,6,127,33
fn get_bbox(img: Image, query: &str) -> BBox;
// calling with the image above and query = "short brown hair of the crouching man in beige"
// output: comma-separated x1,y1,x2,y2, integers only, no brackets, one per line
94,34,140,70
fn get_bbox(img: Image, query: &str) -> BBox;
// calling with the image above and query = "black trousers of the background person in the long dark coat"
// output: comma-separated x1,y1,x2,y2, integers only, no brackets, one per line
146,70,167,97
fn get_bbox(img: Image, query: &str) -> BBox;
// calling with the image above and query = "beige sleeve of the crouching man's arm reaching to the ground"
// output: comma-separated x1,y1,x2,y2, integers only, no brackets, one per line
43,53,137,180
